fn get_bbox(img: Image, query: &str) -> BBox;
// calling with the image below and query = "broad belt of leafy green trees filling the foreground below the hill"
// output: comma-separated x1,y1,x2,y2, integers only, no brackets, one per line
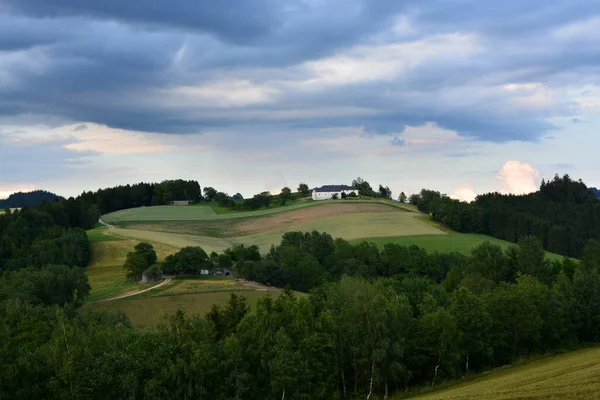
5,233,600,399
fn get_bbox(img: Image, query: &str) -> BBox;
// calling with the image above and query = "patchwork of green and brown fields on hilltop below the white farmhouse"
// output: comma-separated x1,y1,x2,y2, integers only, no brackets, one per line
102,200,447,252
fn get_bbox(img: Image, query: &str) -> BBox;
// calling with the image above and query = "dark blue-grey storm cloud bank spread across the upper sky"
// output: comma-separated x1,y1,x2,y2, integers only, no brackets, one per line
0,0,600,142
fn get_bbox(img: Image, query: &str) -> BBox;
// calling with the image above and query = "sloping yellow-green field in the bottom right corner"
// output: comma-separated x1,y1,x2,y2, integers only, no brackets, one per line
400,348,600,400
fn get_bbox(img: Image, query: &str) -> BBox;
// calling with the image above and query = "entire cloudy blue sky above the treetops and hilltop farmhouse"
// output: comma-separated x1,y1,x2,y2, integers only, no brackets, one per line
0,0,600,200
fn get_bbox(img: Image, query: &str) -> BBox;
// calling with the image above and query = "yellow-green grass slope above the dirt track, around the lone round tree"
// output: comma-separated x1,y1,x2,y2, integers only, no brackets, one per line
87,240,177,302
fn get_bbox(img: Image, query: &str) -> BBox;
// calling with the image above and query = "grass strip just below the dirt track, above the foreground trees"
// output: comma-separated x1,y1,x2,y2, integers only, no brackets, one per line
91,289,292,328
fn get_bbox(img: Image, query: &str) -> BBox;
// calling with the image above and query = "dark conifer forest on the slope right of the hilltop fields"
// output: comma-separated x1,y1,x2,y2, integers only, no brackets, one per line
410,175,600,257
